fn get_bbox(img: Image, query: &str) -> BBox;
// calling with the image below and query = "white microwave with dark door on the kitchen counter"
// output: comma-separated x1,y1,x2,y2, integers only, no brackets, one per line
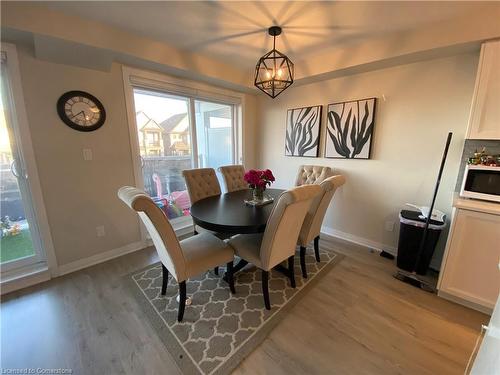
460,165,500,202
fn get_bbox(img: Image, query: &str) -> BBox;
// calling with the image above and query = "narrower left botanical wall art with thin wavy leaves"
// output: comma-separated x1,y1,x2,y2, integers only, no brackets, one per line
285,105,323,158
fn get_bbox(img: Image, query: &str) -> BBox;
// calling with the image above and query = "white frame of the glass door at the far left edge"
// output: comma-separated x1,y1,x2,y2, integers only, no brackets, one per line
1,43,57,284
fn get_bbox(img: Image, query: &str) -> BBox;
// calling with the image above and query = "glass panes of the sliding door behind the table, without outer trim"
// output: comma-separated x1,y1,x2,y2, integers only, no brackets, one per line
133,87,235,227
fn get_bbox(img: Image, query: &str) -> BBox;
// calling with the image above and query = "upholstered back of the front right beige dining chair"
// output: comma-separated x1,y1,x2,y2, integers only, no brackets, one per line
260,185,321,271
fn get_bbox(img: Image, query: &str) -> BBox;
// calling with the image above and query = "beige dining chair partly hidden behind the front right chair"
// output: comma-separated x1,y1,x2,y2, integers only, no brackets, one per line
298,175,345,278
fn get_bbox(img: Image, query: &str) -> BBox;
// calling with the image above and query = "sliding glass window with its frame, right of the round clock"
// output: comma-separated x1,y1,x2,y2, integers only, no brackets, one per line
123,67,243,233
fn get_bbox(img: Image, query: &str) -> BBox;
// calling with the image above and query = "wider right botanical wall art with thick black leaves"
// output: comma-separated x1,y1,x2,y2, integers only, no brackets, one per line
325,98,376,159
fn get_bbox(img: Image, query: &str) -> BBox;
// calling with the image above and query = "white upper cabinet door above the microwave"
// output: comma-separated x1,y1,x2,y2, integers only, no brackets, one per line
467,41,500,139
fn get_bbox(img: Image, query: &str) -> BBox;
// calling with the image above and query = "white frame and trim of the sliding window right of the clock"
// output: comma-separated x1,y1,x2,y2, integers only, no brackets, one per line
122,66,245,241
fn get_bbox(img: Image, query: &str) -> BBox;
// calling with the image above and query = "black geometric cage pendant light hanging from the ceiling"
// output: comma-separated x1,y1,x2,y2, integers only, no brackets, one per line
254,26,294,98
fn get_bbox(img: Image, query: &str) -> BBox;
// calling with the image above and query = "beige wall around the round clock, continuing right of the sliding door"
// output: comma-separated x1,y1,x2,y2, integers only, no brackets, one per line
14,45,255,270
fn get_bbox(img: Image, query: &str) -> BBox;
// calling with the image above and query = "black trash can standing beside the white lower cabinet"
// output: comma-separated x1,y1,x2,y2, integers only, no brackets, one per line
397,210,446,275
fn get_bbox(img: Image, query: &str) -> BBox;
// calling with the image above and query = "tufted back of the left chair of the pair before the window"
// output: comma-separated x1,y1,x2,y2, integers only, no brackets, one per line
182,168,221,204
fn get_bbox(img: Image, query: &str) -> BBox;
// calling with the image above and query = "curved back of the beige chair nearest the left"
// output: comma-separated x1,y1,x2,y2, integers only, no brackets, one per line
118,186,187,282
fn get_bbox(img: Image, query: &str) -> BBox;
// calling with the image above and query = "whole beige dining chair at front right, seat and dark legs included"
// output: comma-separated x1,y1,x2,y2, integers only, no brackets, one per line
228,185,321,310
